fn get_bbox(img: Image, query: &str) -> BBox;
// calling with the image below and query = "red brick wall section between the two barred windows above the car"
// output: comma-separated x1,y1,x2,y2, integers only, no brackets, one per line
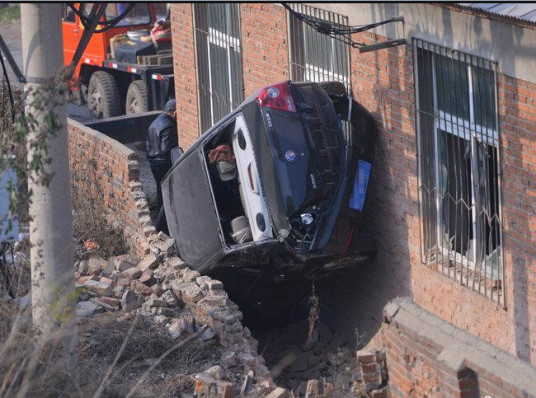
240,3,290,97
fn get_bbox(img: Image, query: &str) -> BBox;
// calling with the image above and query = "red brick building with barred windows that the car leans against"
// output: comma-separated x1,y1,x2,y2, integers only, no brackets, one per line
171,3,536,396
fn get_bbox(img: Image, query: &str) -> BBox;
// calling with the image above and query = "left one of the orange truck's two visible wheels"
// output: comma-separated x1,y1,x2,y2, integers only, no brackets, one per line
87,70,121,119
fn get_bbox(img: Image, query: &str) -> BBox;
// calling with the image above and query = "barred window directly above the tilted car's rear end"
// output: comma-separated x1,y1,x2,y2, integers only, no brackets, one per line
289,3,350,87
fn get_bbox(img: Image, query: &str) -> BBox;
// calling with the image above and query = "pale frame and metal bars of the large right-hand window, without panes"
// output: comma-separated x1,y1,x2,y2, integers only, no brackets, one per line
413,38,506,306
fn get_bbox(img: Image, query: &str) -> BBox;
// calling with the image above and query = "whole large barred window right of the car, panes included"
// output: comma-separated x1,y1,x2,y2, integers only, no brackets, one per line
413,39,505,305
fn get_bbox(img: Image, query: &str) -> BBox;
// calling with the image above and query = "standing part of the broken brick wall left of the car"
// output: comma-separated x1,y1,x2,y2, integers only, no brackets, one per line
67,119,155,256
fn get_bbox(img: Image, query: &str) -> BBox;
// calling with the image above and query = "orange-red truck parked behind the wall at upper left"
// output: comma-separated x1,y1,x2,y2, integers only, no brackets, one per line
62,3,174,118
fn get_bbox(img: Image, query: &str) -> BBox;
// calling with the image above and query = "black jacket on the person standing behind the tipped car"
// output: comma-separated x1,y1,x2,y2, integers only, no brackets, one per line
145,113,179,161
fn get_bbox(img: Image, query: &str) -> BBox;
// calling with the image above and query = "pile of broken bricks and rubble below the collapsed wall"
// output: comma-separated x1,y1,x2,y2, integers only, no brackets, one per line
75,233,284,398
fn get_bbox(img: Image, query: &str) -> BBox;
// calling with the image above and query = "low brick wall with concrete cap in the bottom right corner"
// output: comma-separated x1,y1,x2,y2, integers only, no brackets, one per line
381,298,536,398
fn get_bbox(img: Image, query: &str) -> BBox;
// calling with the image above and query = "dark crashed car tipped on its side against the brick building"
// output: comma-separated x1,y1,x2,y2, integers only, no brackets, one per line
162,81,376,300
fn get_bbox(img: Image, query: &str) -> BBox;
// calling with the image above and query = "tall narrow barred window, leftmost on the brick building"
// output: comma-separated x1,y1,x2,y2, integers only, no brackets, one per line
194,3,244,132
